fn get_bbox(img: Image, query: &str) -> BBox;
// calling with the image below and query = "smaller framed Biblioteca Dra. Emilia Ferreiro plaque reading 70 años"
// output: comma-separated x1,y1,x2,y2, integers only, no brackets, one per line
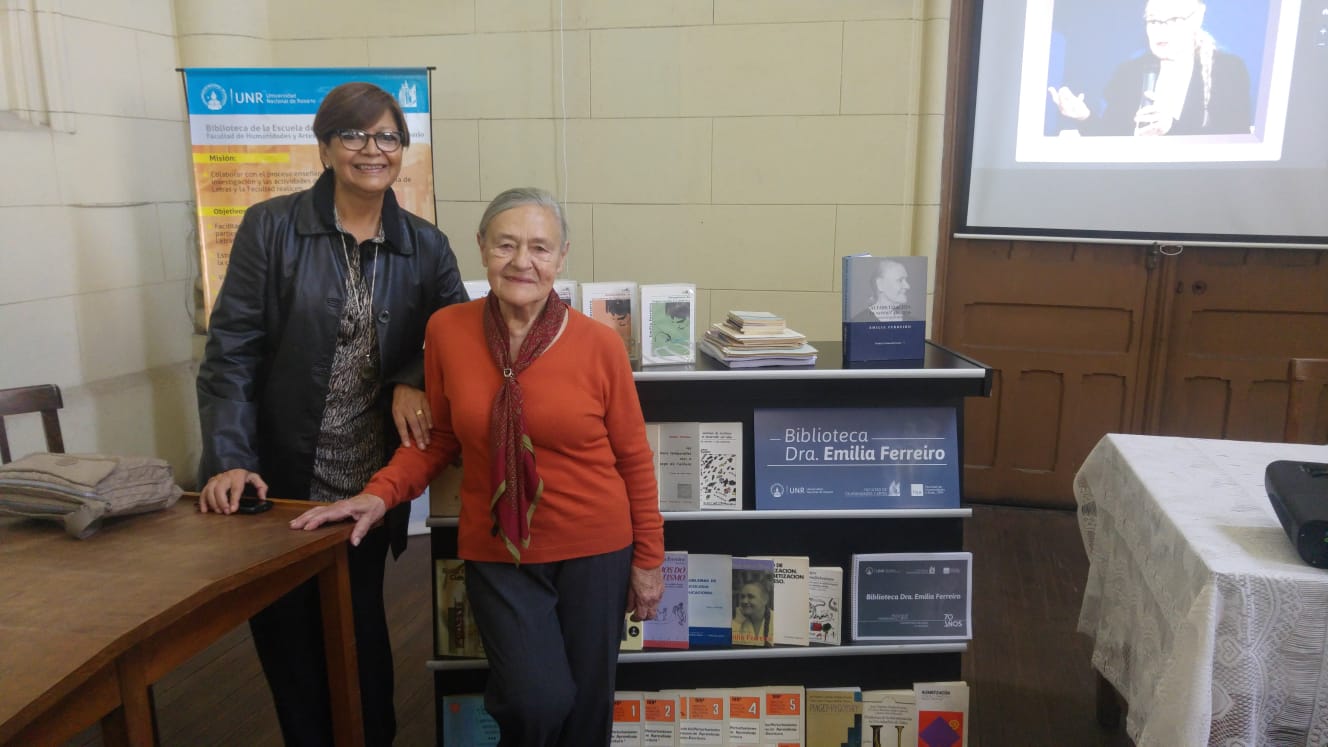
849,553,973,641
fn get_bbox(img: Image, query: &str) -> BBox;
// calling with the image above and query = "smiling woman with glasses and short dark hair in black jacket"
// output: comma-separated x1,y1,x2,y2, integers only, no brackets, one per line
198,82,466,746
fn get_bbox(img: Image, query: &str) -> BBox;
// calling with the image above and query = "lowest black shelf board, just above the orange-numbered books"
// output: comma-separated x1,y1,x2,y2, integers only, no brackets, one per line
425,641,968,671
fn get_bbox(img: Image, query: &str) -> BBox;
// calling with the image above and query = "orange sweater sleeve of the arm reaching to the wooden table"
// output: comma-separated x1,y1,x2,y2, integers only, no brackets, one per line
364,308,461,509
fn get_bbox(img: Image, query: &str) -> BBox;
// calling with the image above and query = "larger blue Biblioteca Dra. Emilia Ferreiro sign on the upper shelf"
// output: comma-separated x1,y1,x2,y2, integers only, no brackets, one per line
753,407,959,509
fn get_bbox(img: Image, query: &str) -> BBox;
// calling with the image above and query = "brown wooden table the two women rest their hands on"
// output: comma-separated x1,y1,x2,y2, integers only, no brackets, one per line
0,498,364,746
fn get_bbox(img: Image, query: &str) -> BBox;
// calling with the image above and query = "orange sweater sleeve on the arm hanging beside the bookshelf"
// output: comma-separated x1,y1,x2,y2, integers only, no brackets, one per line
603,330,664,569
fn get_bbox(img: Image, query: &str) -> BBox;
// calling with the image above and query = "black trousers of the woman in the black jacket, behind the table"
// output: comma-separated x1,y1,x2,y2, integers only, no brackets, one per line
250,526,397,747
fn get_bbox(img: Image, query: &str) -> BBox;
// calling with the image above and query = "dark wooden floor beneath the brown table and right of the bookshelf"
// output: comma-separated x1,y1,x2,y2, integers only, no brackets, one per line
70,506,1130,747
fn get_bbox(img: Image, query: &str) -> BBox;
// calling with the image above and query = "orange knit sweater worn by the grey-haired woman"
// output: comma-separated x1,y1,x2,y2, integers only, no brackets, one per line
364,300,664,569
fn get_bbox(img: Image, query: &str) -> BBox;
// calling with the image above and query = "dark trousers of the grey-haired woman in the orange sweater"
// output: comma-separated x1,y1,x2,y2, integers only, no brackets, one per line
466,546,632,747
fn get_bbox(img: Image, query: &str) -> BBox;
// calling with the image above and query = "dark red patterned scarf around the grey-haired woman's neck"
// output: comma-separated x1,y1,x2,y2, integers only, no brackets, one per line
485,291,567,564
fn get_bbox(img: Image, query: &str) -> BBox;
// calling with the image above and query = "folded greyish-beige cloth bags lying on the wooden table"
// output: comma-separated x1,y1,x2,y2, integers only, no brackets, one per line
0,452,182,540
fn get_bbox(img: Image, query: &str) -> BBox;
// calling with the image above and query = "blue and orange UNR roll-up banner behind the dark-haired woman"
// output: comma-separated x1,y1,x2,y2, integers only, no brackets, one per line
182,68,436,320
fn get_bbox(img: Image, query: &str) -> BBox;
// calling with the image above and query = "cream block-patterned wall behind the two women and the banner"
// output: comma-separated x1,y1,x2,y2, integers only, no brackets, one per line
0,0,948,475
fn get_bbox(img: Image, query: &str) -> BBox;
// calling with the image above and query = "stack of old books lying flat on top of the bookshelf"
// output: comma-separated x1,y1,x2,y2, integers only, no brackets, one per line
699,311,817,368
